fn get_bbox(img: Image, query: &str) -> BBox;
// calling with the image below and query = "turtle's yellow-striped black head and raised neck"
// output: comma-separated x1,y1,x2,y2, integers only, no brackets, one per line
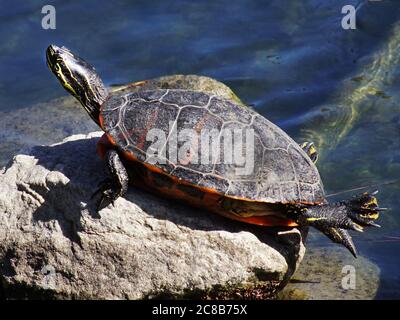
46,45,108,125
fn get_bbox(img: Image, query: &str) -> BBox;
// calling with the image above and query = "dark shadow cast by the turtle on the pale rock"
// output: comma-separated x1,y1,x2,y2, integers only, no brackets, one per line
29,136,307,280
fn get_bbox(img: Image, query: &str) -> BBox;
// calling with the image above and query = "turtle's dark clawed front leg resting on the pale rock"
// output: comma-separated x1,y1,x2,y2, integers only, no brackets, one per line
91,149,129,211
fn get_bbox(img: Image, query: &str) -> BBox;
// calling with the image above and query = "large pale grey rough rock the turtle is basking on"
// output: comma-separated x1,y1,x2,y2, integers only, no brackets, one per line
0,133,305,299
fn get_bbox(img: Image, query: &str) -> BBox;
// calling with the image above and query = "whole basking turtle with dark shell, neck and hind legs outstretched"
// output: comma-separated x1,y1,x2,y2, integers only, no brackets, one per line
46,45,383,257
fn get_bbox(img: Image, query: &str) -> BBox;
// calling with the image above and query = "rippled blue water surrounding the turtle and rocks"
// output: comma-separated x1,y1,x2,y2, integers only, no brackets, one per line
0,0,400,299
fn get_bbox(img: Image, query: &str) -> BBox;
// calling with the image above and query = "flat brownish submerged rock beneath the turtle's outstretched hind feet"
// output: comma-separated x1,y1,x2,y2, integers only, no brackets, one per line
279,246,380,300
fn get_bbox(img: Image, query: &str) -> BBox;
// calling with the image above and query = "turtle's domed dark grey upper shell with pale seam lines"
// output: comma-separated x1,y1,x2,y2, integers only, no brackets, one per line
100,89,324,204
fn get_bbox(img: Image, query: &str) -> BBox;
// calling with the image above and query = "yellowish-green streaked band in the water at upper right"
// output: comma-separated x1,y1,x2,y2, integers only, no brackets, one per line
301,24,400,155
